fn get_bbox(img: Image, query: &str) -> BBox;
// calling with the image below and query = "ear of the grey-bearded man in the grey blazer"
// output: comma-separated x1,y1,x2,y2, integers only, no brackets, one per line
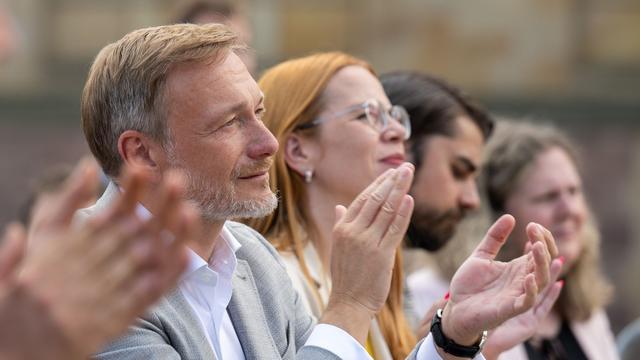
118,130,166,176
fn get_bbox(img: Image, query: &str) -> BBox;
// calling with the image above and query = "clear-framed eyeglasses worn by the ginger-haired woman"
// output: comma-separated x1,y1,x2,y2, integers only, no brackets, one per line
297,99,411,140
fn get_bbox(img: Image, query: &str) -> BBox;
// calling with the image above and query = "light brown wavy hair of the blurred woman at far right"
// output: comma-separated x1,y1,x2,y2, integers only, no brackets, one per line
481,121,612,321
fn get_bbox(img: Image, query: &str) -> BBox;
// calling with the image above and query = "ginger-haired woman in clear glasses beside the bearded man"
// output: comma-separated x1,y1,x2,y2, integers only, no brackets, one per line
242,52,416,359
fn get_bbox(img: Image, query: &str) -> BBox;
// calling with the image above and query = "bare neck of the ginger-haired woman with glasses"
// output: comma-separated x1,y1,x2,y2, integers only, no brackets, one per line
307,186,350,274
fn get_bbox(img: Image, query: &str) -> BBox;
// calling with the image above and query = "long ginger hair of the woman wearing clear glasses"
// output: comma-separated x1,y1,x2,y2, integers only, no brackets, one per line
247,52,415,358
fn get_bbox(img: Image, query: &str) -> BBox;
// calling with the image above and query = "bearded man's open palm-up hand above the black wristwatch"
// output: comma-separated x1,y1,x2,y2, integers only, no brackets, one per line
442,215,557,345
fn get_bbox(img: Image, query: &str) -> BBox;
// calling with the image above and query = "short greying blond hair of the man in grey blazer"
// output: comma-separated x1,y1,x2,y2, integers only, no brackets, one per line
80,24,243,177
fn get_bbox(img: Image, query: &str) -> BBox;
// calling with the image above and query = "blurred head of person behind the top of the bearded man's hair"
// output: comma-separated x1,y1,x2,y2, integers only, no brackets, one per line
175,0,258,75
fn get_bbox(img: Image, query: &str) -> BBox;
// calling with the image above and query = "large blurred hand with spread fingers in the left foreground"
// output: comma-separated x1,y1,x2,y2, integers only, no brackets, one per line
0,163,198,359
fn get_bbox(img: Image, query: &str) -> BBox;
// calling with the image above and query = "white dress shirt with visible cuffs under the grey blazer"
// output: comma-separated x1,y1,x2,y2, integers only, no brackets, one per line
137,205,484,360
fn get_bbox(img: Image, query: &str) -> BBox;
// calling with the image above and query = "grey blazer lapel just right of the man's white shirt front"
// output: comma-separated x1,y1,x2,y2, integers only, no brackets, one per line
228,259,280,359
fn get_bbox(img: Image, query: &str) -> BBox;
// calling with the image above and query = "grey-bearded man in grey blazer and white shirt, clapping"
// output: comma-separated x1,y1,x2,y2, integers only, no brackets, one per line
78,24,550,359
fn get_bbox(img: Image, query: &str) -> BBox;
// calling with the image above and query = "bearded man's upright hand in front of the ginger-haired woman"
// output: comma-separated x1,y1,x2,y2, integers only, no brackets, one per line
321,163,414,343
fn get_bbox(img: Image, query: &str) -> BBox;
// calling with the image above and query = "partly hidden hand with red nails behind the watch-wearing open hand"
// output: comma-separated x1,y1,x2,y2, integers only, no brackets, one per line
482,259,562,359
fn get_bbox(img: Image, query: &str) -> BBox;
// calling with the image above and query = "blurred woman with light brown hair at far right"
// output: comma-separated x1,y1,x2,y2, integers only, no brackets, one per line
482,122,618,360
